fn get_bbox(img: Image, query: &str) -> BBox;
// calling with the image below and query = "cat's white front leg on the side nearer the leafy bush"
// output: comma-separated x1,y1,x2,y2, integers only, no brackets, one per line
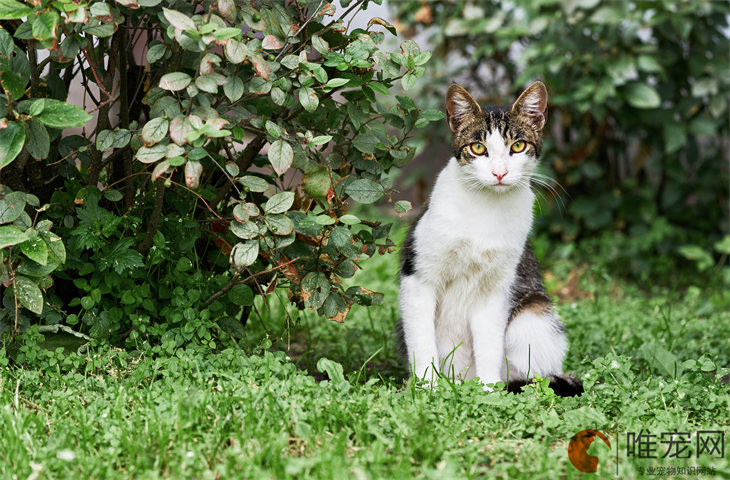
399,275,439,383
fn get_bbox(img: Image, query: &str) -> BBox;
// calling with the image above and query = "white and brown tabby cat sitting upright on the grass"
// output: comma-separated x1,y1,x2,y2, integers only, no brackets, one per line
399,81,583,396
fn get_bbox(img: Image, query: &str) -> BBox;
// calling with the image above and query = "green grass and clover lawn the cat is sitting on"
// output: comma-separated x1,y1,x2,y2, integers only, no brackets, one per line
0,223,730,479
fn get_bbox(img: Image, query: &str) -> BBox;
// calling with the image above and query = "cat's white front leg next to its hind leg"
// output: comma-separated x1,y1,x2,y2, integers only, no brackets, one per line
469,293,509,390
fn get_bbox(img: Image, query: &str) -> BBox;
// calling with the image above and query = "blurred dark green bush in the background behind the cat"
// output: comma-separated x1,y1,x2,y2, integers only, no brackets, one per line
393,0,730,273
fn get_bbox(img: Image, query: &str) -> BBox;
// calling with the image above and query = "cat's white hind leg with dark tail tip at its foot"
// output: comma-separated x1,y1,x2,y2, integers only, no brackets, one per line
502,303,583,396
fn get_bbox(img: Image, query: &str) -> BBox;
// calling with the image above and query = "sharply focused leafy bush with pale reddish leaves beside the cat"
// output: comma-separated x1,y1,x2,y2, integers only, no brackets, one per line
0,0,441,350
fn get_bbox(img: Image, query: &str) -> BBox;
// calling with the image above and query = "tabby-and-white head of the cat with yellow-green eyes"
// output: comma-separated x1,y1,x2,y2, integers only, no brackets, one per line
446,82,547,192
